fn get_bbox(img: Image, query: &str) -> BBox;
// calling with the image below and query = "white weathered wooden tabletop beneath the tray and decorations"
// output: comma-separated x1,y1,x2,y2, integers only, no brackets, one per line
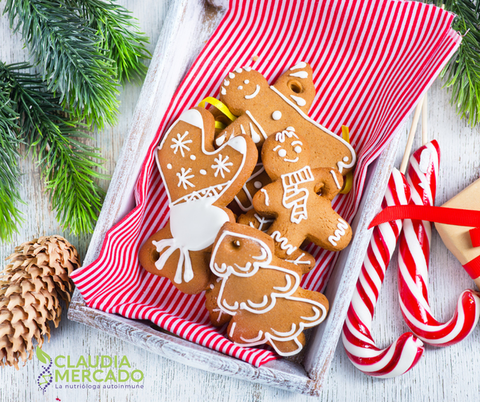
0,0,480,402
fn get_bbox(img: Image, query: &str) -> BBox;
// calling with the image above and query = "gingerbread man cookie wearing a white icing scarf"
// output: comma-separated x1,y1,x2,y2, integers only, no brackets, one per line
253,127,352,258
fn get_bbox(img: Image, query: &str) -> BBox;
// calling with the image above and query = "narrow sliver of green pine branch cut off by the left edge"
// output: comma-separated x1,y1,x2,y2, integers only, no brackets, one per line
0,77,23,240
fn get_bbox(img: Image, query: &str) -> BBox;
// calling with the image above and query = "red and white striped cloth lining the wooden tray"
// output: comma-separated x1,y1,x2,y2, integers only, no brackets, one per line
72,0,460,366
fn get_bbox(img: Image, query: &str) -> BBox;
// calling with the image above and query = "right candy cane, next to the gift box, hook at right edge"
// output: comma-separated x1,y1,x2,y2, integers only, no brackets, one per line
398,141,480,346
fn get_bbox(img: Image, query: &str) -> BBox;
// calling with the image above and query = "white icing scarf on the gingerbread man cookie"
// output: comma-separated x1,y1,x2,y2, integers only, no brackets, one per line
281,166,314,224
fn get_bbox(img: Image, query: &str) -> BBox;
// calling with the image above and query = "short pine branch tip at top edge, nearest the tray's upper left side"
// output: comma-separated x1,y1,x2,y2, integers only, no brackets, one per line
69,0,151,83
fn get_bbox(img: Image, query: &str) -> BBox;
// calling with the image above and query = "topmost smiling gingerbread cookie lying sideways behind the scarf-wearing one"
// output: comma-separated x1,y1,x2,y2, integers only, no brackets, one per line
216,62,356,175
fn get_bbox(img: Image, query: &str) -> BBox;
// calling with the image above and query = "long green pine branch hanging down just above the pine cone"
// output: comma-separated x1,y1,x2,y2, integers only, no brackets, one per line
0,63,105,235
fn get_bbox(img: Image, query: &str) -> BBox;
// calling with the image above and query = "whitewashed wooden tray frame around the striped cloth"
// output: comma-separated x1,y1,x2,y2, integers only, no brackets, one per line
68,0,398,395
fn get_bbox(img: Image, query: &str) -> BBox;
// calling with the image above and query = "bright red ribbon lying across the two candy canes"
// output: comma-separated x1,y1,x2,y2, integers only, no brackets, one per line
368,205,480,247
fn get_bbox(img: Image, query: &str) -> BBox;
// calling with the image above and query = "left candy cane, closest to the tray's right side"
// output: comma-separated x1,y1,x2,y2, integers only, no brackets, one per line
342,169,424,378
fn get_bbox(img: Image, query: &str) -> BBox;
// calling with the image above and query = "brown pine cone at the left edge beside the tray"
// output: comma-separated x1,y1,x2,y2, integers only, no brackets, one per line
0,236,79,370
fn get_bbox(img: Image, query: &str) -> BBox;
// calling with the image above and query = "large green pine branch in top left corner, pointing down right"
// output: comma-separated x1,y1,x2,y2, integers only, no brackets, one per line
4,0,118,128
